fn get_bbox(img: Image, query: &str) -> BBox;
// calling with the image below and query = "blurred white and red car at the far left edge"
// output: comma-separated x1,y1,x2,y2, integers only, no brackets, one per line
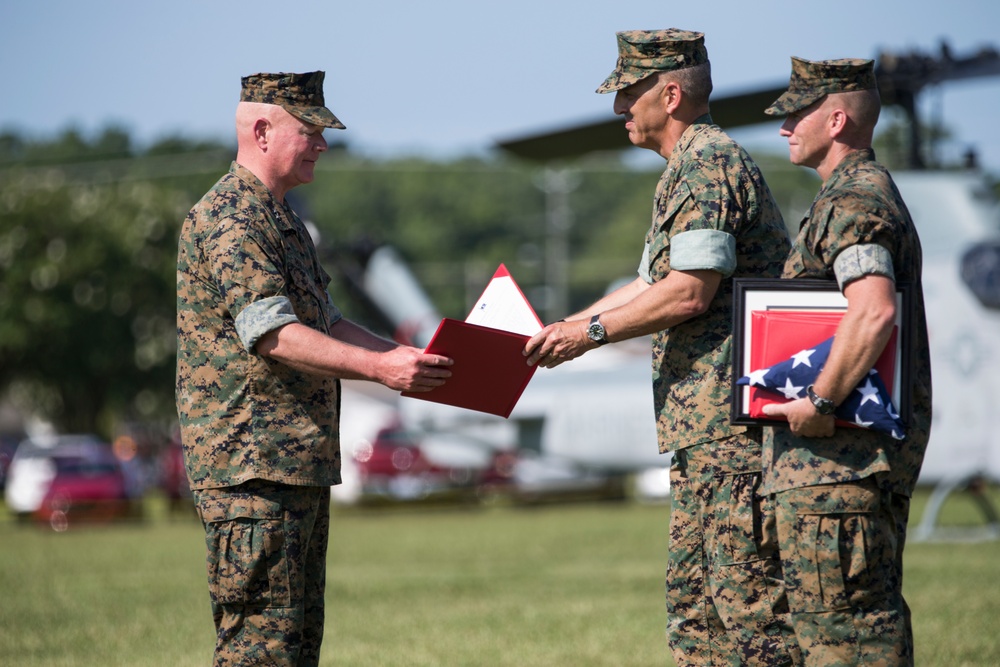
4,435,134,531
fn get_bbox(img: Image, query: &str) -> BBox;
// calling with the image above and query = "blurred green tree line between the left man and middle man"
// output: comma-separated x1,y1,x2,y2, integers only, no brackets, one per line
308,156,658,317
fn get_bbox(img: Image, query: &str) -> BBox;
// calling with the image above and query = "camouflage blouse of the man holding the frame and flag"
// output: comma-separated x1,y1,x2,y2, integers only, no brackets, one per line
762,149,931,495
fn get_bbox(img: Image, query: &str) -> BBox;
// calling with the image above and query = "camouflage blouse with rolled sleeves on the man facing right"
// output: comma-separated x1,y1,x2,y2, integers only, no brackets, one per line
177,163,340,489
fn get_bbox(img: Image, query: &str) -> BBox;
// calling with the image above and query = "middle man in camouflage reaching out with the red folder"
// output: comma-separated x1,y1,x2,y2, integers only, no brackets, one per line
529,29,796,665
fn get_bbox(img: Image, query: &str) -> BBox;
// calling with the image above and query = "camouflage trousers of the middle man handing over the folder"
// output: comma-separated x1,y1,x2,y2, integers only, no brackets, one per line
666,435,798,667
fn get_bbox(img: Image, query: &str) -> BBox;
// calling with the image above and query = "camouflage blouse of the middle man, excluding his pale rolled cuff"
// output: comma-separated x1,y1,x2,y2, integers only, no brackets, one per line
646,115,789,452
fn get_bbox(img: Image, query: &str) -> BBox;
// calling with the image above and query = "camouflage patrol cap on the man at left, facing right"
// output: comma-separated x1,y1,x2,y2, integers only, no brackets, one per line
240,72,346,130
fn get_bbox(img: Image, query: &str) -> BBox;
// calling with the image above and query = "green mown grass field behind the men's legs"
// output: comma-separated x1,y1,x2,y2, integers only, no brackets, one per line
0,489,1000,667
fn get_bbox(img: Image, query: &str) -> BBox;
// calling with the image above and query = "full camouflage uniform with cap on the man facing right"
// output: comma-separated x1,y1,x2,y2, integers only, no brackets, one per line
177,72,350,665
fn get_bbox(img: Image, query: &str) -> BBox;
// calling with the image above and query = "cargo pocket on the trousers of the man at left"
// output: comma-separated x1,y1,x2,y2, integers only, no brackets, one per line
200,494,290,607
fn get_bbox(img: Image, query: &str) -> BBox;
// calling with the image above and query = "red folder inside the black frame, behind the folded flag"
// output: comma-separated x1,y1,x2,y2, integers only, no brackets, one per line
747,310,899,426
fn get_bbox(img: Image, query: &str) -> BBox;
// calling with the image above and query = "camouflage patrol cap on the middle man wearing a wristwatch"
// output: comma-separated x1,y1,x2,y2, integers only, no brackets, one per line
597,28,708,93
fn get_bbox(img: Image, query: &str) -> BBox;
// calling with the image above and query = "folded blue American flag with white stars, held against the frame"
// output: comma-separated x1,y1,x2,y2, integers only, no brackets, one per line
736,336,906,440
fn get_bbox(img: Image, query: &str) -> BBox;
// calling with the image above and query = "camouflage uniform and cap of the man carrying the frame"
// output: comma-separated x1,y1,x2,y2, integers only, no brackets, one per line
762,58,931,666
